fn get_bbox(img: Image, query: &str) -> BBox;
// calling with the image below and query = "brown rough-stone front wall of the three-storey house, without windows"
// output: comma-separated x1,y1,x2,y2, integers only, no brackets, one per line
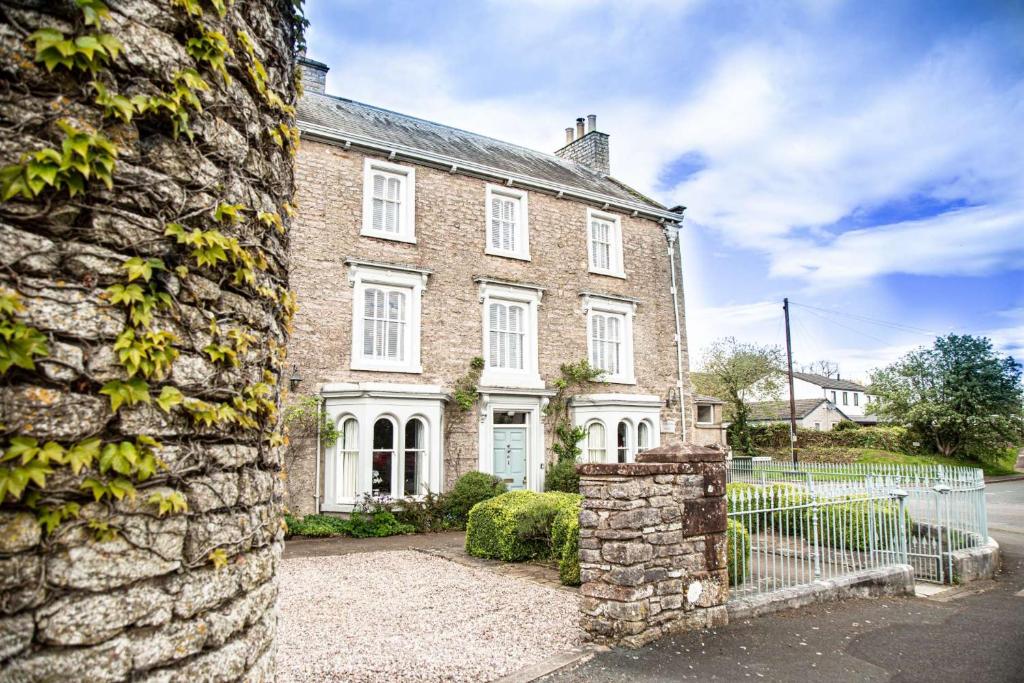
287,137,690,513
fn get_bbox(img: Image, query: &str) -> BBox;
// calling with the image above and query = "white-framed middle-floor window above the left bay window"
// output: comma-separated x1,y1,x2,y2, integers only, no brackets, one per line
347,260,429,373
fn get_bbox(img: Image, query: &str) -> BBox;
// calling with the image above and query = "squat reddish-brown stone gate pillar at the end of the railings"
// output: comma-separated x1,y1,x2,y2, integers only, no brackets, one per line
578,444,729,647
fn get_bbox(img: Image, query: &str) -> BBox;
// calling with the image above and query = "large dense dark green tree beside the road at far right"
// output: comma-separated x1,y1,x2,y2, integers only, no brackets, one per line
868,335,1024,458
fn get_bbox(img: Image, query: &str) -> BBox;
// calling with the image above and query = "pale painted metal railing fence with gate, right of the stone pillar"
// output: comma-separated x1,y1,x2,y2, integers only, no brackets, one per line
726,460,988,596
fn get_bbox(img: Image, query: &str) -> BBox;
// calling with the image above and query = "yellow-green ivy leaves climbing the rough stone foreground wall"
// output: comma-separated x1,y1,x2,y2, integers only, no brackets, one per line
0,0,305,566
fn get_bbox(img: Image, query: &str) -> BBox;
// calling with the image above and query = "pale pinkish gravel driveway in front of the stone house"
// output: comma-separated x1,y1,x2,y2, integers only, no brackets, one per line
278,551,581,683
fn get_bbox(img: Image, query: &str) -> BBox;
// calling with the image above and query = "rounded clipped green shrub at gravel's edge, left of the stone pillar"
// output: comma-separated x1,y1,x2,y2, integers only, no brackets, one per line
466,490,582,562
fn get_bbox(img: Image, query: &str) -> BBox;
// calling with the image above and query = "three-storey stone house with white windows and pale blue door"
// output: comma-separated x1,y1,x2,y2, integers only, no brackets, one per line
287,58,693,513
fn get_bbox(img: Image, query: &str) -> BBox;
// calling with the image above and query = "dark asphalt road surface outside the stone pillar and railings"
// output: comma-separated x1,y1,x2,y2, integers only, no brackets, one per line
542,481,1024,683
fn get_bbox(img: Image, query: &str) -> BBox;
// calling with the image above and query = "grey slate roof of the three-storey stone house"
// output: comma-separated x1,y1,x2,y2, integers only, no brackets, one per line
297,92,666,211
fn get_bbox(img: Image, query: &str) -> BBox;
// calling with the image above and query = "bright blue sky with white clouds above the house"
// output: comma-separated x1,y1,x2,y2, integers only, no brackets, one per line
306,0,1024,378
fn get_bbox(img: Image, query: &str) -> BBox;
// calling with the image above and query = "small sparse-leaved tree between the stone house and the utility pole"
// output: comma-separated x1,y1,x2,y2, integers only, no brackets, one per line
691,337,783,453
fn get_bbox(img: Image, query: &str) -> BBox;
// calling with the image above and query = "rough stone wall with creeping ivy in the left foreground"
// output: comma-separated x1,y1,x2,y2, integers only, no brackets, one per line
0,0,303,681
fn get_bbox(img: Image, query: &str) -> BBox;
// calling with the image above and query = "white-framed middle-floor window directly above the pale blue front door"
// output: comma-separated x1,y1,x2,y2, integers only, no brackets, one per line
477,279,544,388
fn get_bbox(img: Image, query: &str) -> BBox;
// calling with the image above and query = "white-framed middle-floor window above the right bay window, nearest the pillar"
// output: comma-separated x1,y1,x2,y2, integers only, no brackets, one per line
584,294,636,384
